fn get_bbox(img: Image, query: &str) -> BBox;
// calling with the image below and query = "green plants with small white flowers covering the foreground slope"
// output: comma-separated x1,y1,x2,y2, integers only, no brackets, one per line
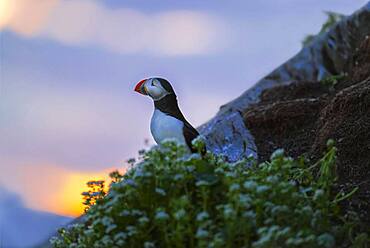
51,140,368,248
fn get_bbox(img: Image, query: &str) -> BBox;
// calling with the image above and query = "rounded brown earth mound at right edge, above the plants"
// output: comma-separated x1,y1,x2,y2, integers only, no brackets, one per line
311,78,370,223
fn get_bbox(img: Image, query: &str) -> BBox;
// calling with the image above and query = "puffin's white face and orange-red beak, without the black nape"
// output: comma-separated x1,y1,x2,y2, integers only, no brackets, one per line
135,78,170,101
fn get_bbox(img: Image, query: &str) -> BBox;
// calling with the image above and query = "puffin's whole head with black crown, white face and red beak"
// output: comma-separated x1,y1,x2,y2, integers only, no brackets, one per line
135,78,176,101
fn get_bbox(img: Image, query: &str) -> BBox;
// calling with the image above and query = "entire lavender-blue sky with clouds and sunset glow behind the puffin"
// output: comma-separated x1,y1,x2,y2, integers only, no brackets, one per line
0,0,366,241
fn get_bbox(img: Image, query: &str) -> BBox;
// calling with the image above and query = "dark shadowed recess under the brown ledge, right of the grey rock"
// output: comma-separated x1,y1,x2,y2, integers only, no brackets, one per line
244,95,325,162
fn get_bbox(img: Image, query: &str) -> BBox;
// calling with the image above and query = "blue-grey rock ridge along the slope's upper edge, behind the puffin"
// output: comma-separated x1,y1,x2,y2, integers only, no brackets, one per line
200,2,370,161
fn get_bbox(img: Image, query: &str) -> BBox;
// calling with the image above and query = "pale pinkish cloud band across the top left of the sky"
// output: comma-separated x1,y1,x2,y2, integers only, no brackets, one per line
0,0,226,56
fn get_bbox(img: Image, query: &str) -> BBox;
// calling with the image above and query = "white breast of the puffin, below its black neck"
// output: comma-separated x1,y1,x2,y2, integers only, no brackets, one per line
150,109,186,144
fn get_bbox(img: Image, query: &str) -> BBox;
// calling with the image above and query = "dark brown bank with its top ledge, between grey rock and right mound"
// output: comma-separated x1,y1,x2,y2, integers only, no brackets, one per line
244,82,328,161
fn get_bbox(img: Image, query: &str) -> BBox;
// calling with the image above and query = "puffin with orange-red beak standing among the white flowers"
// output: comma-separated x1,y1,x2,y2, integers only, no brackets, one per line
135,77,199,153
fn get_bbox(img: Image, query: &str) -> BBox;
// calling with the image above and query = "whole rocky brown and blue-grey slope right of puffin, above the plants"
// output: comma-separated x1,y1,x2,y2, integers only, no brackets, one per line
201,2,370,224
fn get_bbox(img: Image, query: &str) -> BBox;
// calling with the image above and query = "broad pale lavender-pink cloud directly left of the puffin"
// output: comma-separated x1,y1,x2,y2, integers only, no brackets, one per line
0,77,147,170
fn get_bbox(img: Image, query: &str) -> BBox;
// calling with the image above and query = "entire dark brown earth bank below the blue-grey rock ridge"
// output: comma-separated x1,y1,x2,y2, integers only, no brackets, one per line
243,38,370,223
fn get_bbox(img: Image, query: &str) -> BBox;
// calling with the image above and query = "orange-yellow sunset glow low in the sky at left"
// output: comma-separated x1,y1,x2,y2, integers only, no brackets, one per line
0,164,124,217
